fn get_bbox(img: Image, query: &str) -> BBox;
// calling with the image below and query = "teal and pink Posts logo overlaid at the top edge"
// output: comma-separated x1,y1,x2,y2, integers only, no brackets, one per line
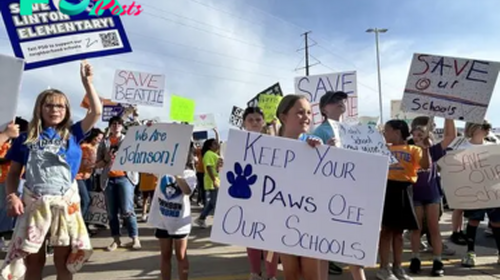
20,0,143,16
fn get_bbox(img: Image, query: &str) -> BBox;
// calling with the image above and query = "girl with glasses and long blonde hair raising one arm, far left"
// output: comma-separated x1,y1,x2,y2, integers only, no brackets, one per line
1,61,102,280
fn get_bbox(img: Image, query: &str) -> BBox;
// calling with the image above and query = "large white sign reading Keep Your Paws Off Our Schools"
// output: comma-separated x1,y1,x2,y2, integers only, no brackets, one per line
211,129,389,266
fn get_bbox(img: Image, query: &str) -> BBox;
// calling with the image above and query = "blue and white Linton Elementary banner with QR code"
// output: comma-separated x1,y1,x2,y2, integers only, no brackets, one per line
0,0,132,70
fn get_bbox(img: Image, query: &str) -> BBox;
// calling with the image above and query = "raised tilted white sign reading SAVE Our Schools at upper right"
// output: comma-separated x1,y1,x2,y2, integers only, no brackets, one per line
401,53,500,123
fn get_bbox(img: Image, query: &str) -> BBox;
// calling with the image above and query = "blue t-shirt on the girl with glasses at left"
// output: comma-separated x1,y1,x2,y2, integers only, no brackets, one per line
5,122,85,180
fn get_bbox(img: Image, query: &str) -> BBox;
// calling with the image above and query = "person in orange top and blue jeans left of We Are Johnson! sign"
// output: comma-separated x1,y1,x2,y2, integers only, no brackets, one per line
96,117,141,251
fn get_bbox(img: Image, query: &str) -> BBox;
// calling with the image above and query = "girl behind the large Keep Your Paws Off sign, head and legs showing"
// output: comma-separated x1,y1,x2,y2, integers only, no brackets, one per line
276,94,322,280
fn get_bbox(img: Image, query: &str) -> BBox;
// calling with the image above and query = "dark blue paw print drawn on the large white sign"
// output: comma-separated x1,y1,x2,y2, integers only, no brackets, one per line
226,162,257,199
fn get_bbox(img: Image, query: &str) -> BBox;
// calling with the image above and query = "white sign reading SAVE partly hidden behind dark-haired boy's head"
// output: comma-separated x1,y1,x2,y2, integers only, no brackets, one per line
295,71,358,127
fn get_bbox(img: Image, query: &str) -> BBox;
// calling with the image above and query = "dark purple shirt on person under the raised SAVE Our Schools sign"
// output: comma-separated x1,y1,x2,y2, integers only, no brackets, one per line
413,143,446,201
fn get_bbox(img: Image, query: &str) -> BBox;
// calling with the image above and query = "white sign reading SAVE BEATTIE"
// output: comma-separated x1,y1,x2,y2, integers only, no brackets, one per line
111,70,165,107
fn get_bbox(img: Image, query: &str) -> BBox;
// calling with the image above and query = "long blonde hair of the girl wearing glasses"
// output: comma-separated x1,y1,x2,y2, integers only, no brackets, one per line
25,89,72,143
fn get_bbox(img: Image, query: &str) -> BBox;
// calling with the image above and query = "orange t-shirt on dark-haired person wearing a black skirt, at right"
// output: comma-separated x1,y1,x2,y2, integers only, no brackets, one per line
388,145,422,183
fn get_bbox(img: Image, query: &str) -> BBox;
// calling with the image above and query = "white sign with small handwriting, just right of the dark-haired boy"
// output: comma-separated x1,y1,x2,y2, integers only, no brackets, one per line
328,120,398,164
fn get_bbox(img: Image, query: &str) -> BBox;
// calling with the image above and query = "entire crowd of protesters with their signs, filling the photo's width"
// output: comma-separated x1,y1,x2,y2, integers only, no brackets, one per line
0,0,500,280
